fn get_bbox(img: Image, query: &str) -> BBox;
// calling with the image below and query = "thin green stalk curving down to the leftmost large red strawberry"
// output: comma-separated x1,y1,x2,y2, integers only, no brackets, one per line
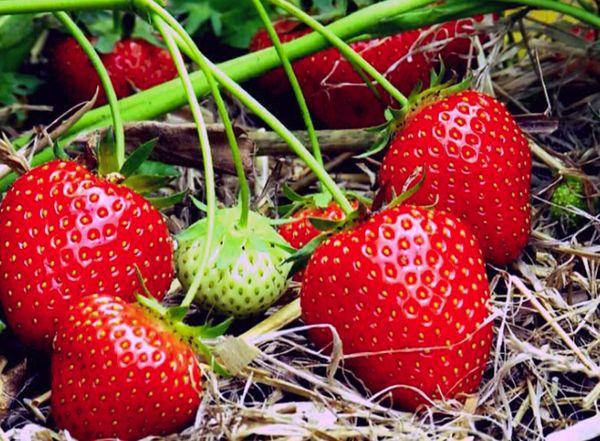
54,11,125,171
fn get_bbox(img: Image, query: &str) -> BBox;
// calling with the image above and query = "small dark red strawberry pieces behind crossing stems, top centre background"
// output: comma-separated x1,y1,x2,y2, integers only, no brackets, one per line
249,20,311,97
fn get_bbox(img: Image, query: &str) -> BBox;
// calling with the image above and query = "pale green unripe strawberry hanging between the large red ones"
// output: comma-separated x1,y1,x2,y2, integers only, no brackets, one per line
175,207,291,318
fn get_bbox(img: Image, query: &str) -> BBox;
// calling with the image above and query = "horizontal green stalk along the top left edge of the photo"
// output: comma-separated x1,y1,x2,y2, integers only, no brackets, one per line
0,0,131,15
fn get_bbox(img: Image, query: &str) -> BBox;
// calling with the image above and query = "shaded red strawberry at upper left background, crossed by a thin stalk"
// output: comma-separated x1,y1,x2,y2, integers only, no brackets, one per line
50,38,177,105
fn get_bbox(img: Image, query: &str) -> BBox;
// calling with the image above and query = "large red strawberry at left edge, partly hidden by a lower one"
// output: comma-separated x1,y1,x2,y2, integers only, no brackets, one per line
0,161,173,349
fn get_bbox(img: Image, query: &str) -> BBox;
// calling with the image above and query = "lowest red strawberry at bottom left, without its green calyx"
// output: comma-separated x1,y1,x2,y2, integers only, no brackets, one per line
51,295,202,440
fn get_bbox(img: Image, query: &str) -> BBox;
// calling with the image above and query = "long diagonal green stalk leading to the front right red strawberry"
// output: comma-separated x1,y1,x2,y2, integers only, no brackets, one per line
137,0,354,213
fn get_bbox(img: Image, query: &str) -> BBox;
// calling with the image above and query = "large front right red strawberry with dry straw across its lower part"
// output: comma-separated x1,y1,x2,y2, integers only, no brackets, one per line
301,206,493,410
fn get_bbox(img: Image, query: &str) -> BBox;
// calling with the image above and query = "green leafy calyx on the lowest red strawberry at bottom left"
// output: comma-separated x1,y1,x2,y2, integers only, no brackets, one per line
137,296,231,376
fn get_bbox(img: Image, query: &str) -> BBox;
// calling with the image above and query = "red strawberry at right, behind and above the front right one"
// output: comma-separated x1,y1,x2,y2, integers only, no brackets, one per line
379,91,531,265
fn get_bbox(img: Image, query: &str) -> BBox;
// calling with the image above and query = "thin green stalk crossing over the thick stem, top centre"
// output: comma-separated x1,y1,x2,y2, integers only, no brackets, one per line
252,0,323,166
